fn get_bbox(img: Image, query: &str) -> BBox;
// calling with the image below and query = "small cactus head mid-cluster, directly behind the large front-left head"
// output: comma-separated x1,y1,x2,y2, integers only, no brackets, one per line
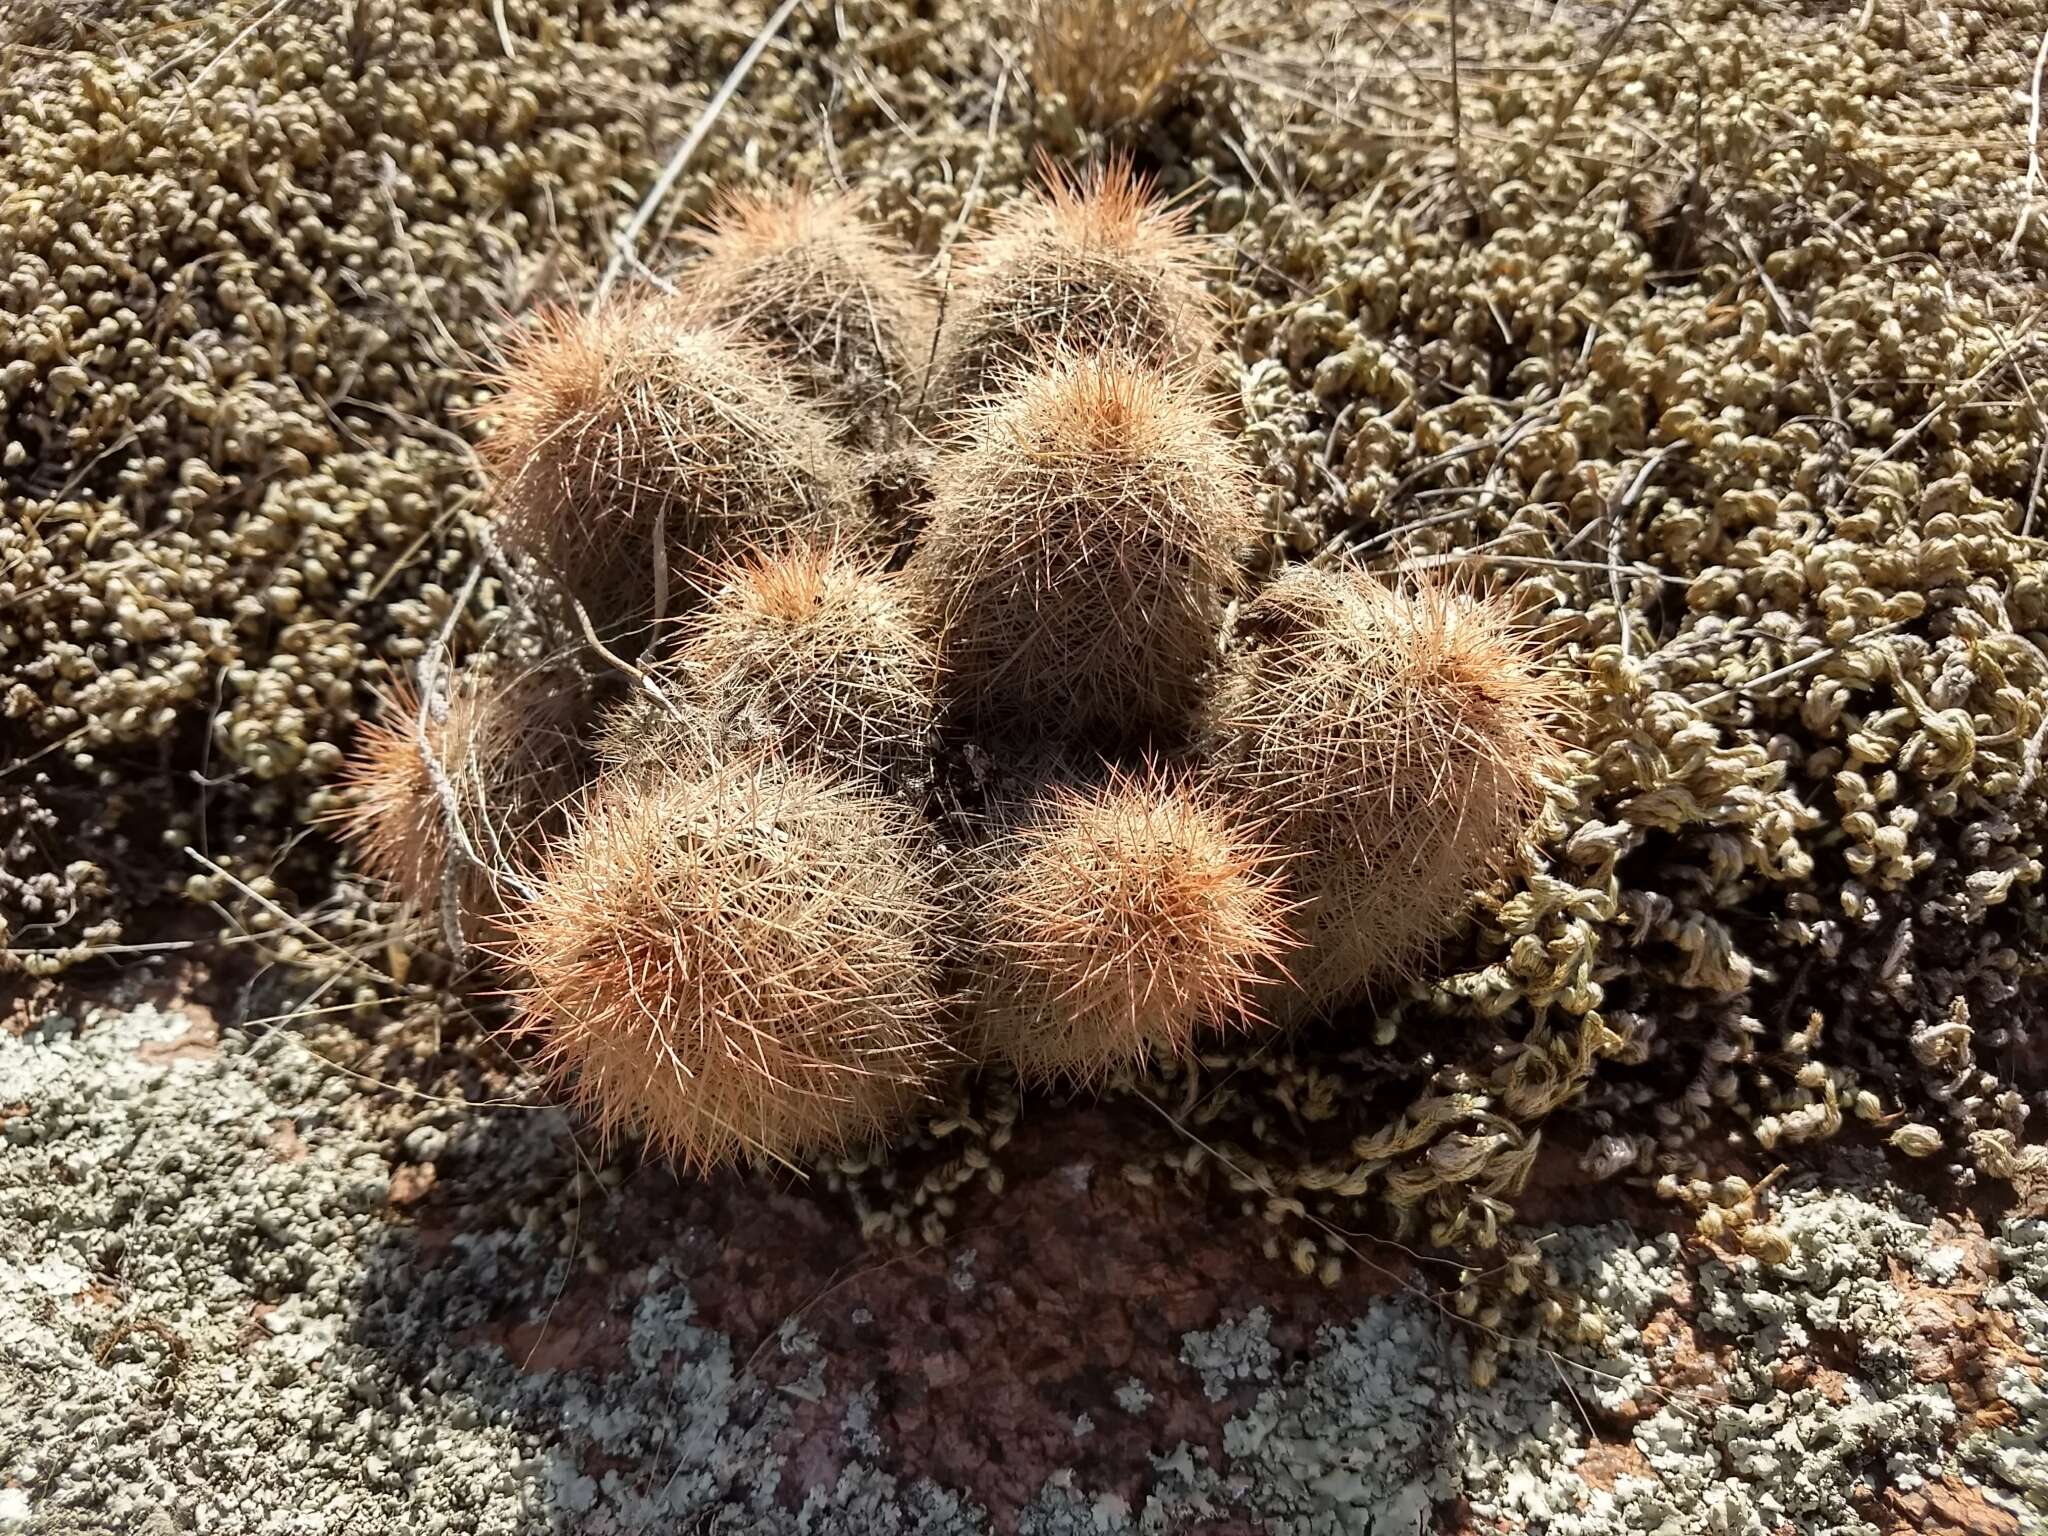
604,545,938,786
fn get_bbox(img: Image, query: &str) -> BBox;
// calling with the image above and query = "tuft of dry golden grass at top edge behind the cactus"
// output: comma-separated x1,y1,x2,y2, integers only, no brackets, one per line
1004,0,1221,129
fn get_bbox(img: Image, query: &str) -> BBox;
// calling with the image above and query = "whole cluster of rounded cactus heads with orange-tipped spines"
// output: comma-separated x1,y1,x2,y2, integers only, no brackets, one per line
346,164,1556,1167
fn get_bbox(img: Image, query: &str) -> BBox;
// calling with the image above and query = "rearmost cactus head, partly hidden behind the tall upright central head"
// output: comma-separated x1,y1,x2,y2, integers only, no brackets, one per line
932,158,1217,412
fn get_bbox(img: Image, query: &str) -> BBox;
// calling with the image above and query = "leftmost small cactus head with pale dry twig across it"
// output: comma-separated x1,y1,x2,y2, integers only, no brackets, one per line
324,670,586,942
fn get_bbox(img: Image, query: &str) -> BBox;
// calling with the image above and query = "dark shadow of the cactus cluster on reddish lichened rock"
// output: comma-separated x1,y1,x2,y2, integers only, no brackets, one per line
344,1108,1448,1536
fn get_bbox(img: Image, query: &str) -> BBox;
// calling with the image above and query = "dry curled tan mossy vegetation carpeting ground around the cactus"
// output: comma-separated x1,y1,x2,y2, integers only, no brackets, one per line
0,0,2048,1359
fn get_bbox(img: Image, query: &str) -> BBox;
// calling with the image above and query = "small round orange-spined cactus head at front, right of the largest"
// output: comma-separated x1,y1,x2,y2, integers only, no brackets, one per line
975,768,1292,1083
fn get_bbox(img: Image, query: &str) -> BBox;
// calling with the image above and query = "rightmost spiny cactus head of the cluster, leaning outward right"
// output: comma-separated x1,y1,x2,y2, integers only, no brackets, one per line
1204,565,1561,1008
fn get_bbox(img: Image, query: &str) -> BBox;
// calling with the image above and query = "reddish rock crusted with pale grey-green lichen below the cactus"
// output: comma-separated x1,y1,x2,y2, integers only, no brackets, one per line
0,978,2048,1536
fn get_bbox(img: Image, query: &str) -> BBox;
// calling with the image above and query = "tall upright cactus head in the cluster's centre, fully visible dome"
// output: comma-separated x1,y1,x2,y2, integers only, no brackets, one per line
913,356,1257,737
